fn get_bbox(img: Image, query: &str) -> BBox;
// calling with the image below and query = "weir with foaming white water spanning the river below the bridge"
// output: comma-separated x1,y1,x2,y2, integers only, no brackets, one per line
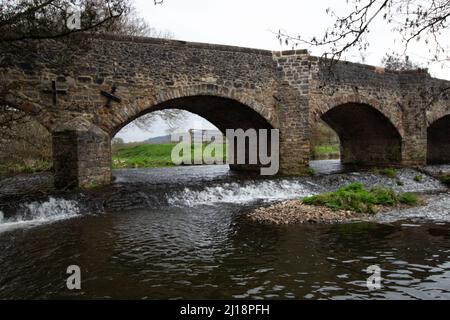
0,162,450,232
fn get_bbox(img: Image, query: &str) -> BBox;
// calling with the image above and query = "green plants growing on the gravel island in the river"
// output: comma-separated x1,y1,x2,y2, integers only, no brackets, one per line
303,183,418,213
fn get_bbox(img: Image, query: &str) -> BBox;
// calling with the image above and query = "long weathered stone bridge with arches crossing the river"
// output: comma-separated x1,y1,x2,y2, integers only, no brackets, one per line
0,36,450,188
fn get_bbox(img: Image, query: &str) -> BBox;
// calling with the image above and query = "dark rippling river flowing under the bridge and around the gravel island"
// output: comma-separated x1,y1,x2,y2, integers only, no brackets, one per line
0,161,450,299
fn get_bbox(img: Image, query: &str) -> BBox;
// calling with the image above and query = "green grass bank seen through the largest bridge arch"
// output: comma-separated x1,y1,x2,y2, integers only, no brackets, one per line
112,144,226,169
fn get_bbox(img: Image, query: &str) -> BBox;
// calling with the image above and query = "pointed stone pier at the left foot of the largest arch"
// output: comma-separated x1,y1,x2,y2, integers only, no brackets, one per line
53,119,111,189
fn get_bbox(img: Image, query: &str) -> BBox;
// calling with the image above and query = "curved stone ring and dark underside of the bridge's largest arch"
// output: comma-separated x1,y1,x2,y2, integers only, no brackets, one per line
105,84,278,136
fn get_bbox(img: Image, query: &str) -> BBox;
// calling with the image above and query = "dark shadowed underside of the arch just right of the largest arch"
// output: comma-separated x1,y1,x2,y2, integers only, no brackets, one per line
321,101,402,165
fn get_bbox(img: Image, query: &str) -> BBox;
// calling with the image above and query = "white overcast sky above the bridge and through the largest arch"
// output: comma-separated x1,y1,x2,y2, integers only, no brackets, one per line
118,0,450,141
